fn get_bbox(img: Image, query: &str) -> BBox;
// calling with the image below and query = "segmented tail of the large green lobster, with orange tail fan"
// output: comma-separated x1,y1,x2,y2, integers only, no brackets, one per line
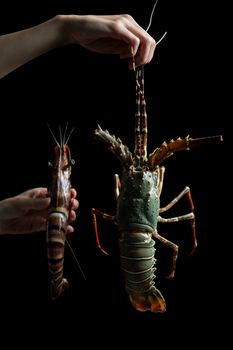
119,232,166,312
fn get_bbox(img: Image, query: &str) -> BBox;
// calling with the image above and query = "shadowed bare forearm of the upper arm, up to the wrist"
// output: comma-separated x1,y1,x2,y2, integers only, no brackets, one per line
0,16,65,78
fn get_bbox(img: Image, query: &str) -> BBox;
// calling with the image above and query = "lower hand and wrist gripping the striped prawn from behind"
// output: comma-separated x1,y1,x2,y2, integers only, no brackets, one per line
0,187,79,235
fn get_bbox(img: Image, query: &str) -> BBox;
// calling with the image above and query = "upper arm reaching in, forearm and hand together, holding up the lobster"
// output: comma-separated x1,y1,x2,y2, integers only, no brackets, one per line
0,14,156,78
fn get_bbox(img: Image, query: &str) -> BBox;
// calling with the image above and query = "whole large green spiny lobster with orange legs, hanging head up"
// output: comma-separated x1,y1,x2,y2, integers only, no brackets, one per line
92,66,222,312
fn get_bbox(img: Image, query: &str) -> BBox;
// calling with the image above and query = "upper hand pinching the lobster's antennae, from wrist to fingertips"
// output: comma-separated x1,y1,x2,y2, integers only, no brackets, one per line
62,14,156,68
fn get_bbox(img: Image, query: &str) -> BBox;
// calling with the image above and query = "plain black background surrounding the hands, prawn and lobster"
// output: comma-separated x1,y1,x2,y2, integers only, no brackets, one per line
0,0,230,347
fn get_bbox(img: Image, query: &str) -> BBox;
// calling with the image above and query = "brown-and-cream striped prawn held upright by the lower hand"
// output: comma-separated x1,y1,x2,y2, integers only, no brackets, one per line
46,130,72,300
